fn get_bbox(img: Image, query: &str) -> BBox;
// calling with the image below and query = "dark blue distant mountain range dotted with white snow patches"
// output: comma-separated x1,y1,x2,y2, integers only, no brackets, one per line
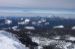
0,16,75,29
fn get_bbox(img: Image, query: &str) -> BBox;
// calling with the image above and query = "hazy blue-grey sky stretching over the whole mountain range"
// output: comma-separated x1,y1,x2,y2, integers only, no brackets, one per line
0,0,75,15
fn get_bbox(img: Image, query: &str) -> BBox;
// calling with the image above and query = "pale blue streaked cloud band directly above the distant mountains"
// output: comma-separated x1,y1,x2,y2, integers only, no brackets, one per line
0,9,75,18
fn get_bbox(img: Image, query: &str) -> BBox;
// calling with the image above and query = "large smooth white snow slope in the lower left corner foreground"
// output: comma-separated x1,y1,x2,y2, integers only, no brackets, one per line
0,30,28,49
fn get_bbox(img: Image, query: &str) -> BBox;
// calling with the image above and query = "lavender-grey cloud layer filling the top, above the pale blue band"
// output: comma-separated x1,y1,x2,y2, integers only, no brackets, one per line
0,0,75,9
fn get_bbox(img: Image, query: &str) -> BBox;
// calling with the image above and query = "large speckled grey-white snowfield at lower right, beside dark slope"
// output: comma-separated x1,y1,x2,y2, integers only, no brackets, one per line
32,36,75,49
